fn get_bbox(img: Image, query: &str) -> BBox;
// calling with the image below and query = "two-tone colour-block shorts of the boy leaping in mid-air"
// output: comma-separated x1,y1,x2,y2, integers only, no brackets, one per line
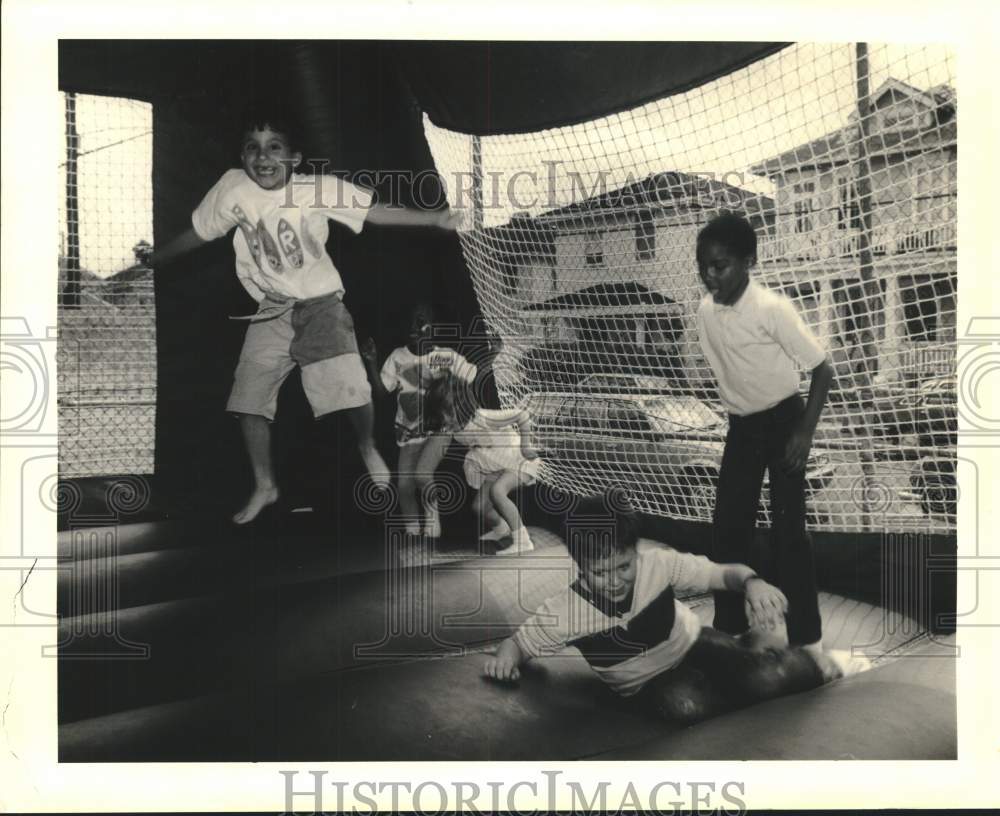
226,292,371,419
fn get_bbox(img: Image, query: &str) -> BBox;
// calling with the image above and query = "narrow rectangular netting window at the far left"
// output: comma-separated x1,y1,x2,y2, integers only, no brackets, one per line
57,93,156,476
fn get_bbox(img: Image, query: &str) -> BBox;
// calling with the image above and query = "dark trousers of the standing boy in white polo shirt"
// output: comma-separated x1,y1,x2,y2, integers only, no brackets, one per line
712,394,822,646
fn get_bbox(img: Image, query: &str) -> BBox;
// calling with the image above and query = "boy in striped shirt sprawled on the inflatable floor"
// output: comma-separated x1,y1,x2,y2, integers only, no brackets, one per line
485,492,862,724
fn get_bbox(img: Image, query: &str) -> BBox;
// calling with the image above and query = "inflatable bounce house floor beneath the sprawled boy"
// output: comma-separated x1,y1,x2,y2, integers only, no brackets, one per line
59,521,956,762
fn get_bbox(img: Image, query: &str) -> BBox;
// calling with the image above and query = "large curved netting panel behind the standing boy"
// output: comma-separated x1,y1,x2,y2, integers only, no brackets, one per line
425,44,957,530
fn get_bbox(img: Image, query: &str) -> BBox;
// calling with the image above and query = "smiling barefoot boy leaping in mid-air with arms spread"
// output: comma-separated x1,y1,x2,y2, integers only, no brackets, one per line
151,105,457,524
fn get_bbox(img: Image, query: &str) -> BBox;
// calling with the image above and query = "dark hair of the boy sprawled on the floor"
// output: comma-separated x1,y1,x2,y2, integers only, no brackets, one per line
563,487,639,566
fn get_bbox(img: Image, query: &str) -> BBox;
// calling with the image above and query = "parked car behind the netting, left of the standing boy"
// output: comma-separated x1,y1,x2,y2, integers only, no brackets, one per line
529,375,836,521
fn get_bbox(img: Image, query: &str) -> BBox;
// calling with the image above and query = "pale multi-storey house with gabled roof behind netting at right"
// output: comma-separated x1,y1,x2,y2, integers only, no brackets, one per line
751,79,958,381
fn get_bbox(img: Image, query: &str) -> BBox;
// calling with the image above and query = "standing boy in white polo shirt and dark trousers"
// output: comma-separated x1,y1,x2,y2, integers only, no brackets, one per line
696,213,833,655
